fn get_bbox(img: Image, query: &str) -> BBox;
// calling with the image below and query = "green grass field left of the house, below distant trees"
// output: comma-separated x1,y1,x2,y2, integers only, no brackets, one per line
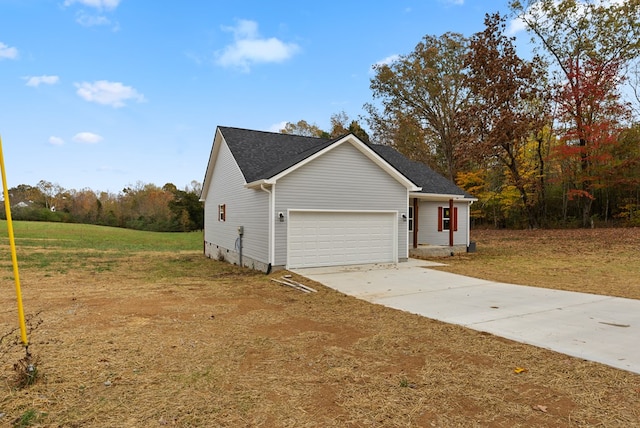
0,221,263,281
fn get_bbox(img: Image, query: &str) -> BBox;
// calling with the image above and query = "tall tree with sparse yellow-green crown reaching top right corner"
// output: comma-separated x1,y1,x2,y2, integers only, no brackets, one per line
510,0,640,226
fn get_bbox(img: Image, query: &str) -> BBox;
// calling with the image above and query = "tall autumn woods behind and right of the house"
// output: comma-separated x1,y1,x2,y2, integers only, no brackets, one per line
364,0,640,227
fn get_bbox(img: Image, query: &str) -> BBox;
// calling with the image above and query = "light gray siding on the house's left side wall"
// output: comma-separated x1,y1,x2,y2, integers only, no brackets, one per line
204,140,269,266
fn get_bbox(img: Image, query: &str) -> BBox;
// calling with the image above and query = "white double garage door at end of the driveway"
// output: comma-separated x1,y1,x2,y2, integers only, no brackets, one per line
287,211,397,268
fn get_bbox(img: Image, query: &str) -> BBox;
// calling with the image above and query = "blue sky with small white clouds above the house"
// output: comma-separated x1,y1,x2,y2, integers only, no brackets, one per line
0,0,526,193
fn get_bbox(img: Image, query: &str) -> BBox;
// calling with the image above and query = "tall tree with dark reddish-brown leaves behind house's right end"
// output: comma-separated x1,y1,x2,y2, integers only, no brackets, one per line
460,14,548,227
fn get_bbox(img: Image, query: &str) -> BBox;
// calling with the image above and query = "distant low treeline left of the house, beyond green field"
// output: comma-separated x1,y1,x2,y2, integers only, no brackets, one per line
0,180,204,232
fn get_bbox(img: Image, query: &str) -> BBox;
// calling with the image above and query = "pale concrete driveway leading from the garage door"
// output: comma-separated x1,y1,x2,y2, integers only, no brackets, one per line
294,259,640,373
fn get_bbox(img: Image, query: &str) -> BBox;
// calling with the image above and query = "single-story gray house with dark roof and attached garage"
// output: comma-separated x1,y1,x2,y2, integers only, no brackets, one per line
201,127,475,272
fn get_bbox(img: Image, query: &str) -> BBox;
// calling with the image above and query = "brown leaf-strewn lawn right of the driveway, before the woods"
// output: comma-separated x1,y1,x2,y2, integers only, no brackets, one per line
432,228,640,299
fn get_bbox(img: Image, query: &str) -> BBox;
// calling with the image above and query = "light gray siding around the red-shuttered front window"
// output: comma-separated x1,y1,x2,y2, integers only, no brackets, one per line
418,201,469,245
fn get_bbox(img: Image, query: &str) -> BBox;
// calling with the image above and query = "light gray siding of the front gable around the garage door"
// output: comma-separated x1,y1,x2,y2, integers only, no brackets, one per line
274,143,408,265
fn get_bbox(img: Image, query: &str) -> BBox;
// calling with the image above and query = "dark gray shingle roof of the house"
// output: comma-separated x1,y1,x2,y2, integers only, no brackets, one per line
218,126,473,198
